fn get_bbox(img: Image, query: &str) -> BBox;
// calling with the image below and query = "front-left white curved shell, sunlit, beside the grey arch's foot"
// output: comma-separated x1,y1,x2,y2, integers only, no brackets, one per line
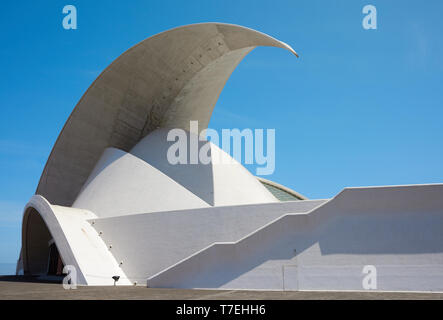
73,146,209,217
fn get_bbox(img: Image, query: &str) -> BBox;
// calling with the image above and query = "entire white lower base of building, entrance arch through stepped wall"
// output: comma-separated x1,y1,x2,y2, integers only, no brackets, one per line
20,184,443,292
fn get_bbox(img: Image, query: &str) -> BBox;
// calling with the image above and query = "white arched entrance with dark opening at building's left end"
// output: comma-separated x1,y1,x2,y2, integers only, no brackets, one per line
21,195,131,285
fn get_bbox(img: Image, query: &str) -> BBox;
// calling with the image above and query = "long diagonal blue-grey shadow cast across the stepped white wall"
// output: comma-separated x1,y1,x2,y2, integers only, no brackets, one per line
148,186,443,288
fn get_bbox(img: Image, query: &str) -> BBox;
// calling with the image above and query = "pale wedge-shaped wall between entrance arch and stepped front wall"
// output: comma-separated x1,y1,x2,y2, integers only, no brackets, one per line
94,200,324,283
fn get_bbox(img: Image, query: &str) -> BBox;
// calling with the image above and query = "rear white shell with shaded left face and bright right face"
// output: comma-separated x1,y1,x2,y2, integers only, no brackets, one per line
130,128,278,209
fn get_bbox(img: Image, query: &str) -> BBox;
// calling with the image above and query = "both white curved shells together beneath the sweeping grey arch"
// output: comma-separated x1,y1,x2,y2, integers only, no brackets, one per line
72,128,279,218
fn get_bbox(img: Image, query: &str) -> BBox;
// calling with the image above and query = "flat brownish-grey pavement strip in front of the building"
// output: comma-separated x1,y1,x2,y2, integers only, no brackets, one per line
0,276,443,300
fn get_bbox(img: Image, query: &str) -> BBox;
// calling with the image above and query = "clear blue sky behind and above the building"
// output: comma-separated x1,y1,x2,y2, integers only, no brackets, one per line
0,0,443,263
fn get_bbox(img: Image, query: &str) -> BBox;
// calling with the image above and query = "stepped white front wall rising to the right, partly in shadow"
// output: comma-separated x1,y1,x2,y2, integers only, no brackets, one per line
148,185,443,291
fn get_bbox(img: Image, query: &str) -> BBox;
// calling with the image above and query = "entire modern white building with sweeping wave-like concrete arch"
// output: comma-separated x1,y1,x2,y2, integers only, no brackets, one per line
17,23,443,291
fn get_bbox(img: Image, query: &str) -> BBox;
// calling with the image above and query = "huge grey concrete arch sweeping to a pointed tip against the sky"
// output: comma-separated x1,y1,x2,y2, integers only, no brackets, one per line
36,23,297,206
